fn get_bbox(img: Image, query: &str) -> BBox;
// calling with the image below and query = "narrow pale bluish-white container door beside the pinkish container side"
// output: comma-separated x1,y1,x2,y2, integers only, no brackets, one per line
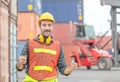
10,22,17,82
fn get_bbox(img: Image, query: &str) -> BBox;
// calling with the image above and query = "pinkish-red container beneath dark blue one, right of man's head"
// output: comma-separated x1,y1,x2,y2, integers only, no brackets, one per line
52,23,76,44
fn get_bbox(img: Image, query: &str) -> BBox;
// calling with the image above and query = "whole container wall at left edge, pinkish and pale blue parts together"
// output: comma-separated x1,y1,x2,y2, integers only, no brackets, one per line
0,0,17,82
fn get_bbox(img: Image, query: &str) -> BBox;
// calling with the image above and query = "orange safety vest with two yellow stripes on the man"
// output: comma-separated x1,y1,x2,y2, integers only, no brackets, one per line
28,40,60,80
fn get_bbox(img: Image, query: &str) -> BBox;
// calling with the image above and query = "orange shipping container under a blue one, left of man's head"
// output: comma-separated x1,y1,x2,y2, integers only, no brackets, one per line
17,12,40,41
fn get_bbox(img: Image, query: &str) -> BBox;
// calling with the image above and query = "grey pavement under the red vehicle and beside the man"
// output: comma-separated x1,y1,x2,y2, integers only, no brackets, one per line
18,67,120,82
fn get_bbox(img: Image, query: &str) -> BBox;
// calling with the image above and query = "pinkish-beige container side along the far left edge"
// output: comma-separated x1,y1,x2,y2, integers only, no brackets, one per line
0,0,10,82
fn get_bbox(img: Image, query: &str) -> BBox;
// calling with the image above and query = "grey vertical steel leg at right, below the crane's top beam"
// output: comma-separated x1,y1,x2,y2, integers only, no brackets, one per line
111,6,118,66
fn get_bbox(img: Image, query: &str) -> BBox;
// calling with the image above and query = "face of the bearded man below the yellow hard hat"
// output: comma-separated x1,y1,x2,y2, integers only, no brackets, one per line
40,20,53,37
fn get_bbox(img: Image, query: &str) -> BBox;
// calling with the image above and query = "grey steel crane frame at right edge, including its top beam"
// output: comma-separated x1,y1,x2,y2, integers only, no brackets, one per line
100,0,120,66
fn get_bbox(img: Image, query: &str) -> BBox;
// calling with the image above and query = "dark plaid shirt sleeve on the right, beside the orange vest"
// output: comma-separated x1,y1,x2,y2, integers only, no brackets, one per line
57,46,67,75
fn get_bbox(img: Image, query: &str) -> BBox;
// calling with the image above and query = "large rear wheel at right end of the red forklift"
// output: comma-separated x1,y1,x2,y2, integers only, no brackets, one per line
97,58,112,70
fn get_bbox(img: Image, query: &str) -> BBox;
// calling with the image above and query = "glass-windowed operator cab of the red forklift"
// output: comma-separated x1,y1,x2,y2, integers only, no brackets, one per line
76,24,95,47
